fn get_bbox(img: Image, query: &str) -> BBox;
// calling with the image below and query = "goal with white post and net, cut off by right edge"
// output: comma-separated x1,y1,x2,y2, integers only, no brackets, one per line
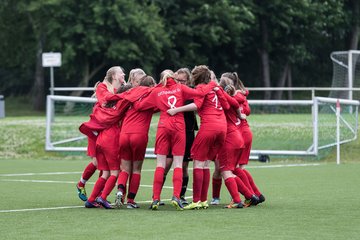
329,50,360,100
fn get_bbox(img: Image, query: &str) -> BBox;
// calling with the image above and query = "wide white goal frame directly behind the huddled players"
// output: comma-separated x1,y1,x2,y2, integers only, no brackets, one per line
45,95,359,159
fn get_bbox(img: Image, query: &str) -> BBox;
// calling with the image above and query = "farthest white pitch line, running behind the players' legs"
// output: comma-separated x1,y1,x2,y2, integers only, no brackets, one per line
0,163,322,177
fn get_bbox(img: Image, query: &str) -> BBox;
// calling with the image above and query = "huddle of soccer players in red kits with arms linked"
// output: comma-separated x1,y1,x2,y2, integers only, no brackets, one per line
76,65,265,210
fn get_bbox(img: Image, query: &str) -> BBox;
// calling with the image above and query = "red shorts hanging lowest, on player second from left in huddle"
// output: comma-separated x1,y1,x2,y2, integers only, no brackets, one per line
96,145,120,171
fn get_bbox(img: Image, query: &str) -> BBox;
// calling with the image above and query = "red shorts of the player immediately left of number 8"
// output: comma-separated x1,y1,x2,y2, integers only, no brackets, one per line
119,132,148,161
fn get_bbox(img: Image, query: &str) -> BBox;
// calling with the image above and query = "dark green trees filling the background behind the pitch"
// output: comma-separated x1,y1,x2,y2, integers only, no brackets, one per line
0,0,360,105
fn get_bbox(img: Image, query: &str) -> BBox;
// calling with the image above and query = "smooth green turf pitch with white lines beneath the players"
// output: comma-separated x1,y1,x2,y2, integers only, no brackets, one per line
0,159,360,240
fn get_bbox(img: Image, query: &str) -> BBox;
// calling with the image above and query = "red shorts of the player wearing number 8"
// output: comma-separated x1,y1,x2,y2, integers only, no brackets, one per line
155,127,186,156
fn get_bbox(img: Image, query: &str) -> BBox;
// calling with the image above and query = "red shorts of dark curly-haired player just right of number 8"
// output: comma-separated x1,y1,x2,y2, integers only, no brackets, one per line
191,127,226,161
